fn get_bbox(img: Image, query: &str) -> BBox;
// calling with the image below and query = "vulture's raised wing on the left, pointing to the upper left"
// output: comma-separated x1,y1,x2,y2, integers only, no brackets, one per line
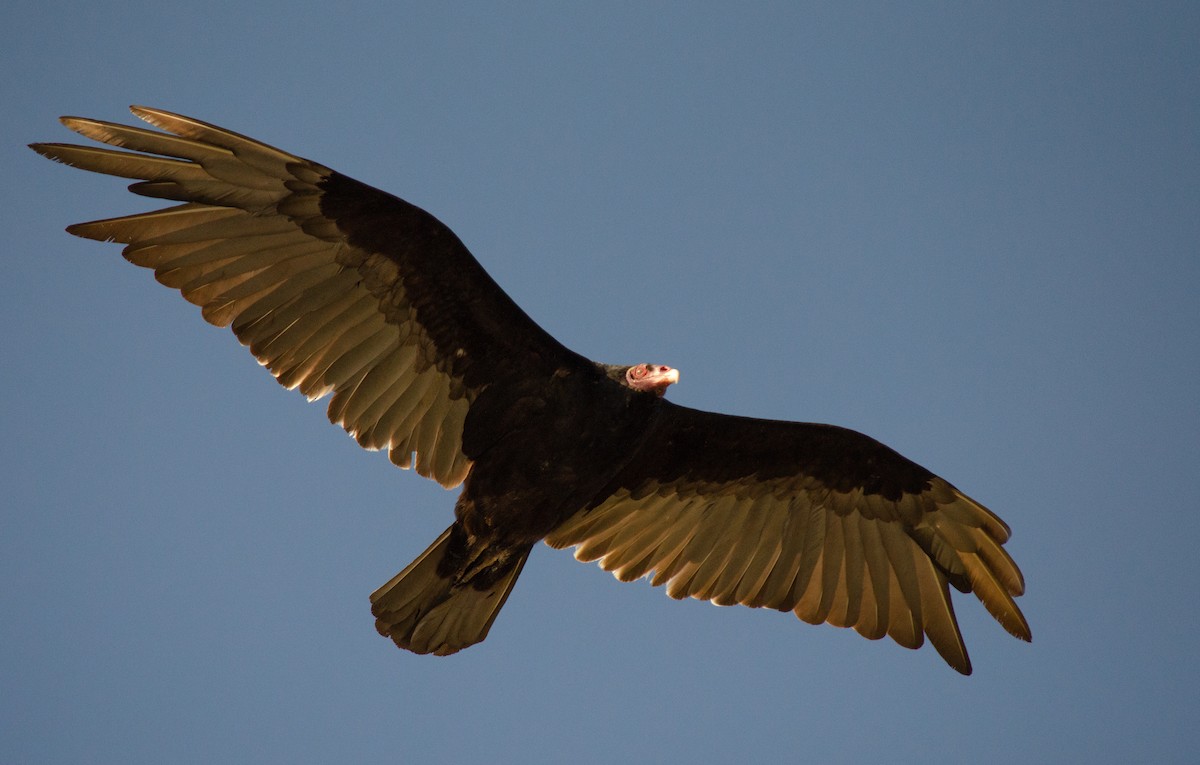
32,107,576,487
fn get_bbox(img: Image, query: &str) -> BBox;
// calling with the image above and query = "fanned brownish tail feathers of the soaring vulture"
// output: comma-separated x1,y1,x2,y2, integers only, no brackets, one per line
371,526,529,656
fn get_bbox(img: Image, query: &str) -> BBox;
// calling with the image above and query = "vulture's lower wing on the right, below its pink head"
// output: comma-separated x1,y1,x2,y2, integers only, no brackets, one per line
546,402,1030,674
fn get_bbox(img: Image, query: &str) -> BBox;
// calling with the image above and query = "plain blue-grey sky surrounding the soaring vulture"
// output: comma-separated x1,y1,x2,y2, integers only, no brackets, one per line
0,1,1200,764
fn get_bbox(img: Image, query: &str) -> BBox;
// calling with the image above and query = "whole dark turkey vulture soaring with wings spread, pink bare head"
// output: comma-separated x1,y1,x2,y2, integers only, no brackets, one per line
31,107,1030,674
